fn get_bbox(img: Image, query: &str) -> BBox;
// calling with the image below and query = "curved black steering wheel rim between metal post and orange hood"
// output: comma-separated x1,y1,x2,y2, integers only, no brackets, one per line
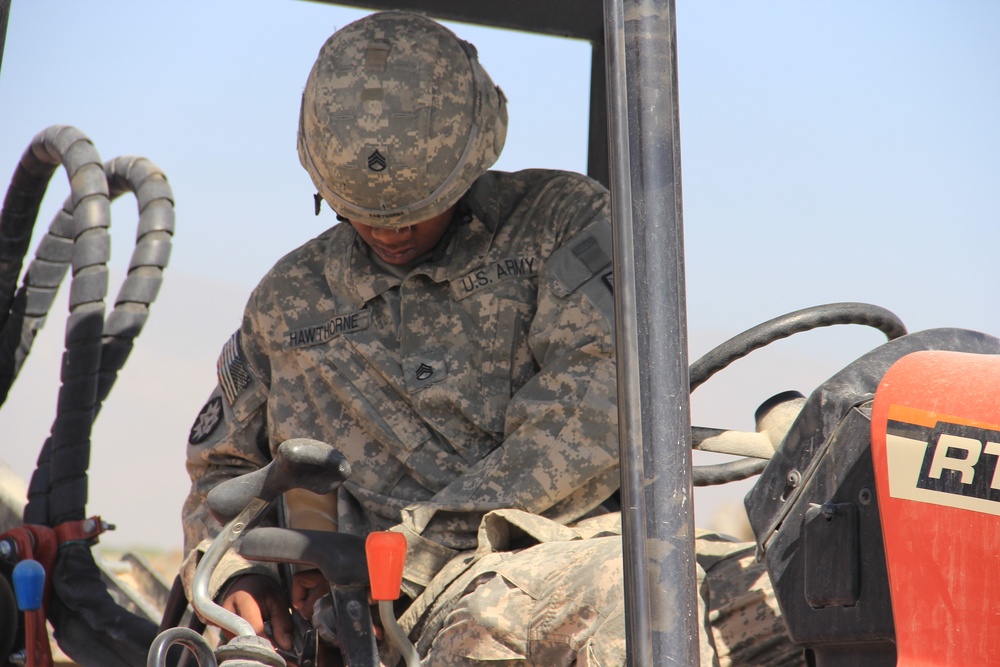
689,302,906,486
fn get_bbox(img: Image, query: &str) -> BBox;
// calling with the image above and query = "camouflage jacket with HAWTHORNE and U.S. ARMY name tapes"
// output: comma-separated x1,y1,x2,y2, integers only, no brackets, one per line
184,170,619,596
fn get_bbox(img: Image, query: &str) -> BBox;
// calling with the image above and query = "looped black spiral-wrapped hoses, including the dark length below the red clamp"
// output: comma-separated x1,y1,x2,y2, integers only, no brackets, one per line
0,126,174,667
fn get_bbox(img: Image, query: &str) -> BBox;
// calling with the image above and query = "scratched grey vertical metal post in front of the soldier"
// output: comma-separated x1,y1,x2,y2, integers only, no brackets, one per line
605,0,699,667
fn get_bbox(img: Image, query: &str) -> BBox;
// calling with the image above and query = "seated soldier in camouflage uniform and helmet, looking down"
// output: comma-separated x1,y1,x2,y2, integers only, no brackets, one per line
184,12,802,667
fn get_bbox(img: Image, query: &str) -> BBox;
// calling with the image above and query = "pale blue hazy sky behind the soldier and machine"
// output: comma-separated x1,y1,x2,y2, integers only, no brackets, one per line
0,0,1000,547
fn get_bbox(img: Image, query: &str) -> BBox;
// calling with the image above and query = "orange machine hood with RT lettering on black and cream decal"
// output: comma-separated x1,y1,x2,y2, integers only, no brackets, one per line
872,351,1000,667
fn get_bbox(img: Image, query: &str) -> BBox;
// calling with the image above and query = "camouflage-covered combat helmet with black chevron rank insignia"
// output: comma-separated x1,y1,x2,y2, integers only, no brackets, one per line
298,11,507,228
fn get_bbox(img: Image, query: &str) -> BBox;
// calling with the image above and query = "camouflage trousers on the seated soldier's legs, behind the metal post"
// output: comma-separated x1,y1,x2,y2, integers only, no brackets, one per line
402,534,806,667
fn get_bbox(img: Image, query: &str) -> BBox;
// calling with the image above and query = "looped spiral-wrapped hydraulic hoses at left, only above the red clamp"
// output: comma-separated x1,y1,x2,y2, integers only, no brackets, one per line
0,126,174,525
